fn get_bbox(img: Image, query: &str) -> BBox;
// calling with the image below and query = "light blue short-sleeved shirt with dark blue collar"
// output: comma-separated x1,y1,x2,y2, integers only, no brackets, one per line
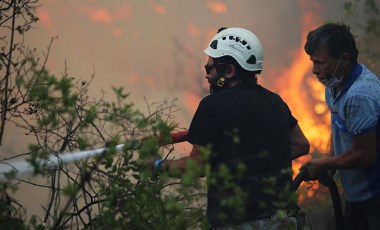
325,64,380,202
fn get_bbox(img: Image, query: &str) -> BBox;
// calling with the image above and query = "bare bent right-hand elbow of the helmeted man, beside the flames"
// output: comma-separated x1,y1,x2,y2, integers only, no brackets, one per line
290,124,310,160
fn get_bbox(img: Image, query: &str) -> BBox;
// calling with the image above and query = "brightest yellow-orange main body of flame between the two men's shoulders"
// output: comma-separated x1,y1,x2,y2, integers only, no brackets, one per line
276,43,330,153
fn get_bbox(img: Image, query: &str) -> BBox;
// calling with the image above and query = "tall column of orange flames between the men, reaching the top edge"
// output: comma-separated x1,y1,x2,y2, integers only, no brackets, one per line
271,0,330,198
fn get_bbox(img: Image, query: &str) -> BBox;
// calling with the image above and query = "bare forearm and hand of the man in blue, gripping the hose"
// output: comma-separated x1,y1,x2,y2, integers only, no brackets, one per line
305,131,376,179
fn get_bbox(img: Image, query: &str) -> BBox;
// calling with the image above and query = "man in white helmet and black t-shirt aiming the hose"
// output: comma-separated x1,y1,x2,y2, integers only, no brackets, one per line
155,28,310,228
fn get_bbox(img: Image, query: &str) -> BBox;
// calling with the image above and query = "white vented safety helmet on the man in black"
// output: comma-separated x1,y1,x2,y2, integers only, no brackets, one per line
204,28,264,71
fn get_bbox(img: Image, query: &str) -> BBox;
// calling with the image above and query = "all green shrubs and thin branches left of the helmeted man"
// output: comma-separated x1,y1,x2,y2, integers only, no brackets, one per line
0,0,205,229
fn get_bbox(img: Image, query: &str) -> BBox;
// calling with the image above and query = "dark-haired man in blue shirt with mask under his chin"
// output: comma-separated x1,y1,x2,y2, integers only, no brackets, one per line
304,23,380,230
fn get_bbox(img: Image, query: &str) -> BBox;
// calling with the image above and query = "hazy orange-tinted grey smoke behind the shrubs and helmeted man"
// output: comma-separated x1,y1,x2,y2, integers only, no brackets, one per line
0,0,350,223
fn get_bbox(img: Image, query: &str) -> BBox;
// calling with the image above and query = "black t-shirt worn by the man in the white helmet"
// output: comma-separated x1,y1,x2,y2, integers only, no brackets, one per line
188,84,297,226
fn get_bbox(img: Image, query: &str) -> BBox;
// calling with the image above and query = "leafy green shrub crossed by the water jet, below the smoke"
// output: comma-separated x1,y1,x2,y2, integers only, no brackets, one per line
0,53,209,229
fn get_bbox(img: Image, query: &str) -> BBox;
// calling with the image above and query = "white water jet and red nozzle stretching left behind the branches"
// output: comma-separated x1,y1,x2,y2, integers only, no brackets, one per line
0,131,187,183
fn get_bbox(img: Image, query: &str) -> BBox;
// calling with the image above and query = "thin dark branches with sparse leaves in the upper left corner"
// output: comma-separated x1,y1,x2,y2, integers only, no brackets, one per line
0,0,38,144
